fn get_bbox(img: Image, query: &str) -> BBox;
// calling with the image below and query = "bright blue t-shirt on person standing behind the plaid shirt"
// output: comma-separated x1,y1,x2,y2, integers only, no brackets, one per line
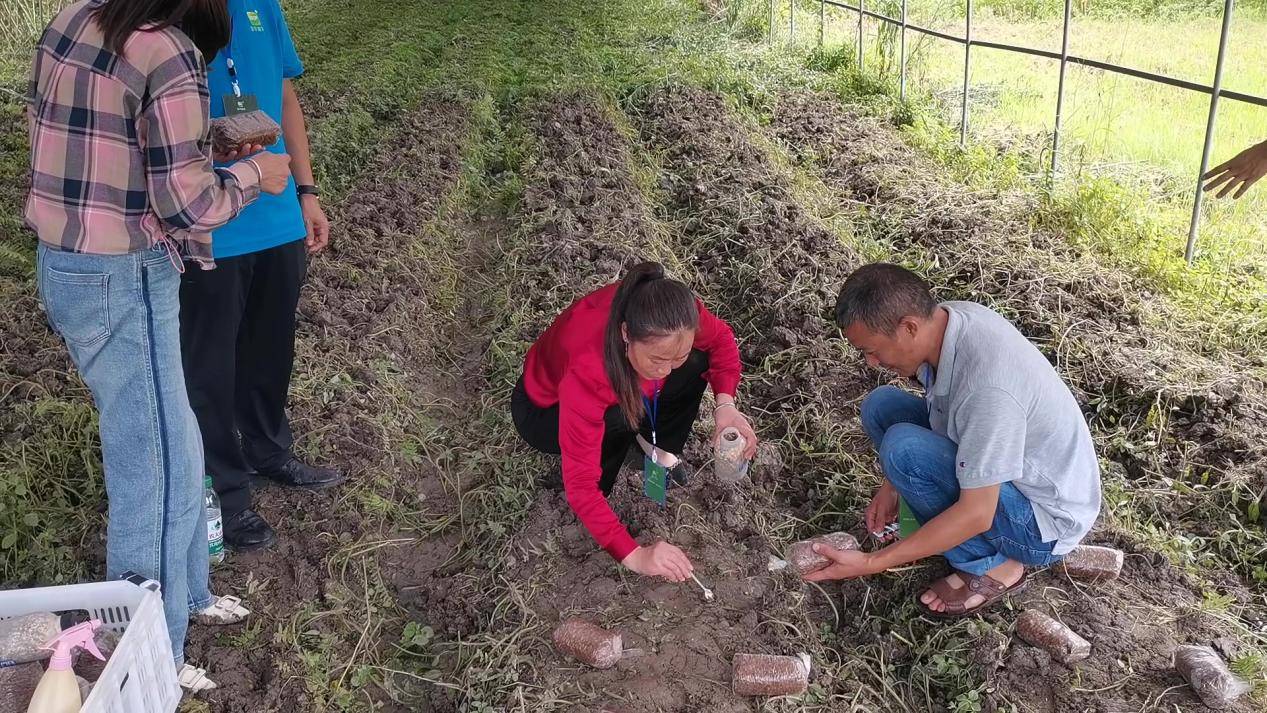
207,0,308,257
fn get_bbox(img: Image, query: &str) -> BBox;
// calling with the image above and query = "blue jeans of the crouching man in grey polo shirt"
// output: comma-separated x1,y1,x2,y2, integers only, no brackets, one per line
862,386,1060,575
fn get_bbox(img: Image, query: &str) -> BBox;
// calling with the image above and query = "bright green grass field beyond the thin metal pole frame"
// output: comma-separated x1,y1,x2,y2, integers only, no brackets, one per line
785,0,1267,358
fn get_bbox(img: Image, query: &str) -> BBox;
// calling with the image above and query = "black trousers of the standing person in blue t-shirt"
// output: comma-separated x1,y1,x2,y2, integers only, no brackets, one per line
180,241,308,521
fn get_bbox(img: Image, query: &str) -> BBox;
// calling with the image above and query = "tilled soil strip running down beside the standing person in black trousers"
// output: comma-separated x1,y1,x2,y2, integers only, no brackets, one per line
188,99,471,713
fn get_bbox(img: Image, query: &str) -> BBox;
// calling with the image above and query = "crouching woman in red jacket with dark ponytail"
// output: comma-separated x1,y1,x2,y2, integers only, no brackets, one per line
511,262,756,581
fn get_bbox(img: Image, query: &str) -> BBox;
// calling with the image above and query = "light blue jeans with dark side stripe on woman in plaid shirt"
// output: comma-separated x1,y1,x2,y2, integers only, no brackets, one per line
38,243,212,666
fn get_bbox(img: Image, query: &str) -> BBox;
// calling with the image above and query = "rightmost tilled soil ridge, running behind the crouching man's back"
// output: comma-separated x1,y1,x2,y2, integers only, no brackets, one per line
769,92,1267,542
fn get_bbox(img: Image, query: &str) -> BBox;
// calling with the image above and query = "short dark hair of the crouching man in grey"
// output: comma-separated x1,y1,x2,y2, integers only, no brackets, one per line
836,262,938,336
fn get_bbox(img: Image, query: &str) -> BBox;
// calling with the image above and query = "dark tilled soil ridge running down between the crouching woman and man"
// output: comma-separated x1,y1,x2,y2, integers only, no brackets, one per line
635,85,875,498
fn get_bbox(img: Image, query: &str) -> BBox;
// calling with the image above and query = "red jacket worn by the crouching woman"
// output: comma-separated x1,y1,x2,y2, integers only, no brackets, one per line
523,284,740,561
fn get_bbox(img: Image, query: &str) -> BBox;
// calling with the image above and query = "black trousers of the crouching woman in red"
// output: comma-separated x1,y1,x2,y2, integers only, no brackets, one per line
511,350,708,496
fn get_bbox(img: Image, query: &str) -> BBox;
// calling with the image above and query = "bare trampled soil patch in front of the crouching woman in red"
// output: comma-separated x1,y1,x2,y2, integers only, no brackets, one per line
507,469,801,712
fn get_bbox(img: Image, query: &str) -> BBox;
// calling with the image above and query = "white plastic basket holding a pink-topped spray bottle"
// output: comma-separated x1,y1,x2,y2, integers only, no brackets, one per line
0,577,180,713
